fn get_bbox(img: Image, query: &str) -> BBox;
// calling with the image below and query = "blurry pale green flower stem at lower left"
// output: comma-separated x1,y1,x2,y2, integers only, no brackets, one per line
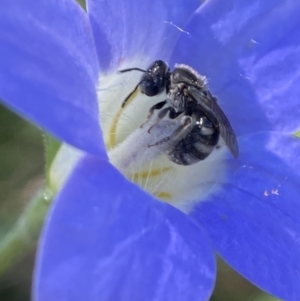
0,189,53,276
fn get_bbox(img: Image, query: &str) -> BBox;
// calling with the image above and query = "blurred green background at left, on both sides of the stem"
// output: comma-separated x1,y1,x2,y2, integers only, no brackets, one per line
0,105,44,301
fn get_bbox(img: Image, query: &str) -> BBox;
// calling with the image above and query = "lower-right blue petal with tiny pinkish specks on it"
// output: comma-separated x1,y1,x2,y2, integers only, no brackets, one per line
192,132,300,301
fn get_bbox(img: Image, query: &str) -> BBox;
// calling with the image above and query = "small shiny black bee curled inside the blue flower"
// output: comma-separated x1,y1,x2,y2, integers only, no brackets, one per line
120,60,239,165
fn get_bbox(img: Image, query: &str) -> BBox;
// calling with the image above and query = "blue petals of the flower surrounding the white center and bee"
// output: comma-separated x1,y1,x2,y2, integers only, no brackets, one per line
0,0,300,301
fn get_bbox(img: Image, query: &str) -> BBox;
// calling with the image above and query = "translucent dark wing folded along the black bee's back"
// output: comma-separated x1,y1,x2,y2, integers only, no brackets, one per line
188,86,239,158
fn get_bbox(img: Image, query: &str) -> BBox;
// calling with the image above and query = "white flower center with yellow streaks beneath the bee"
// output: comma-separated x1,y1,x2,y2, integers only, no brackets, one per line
98,60,228,212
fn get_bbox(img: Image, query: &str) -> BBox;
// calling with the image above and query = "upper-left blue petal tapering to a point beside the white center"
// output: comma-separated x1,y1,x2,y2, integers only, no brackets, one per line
0,0,104,155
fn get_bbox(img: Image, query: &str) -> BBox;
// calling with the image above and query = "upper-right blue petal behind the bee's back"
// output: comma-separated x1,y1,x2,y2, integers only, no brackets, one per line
172,0,300,135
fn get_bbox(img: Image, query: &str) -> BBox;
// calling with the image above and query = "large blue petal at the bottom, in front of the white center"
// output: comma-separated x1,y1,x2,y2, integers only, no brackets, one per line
34,157,215,301
